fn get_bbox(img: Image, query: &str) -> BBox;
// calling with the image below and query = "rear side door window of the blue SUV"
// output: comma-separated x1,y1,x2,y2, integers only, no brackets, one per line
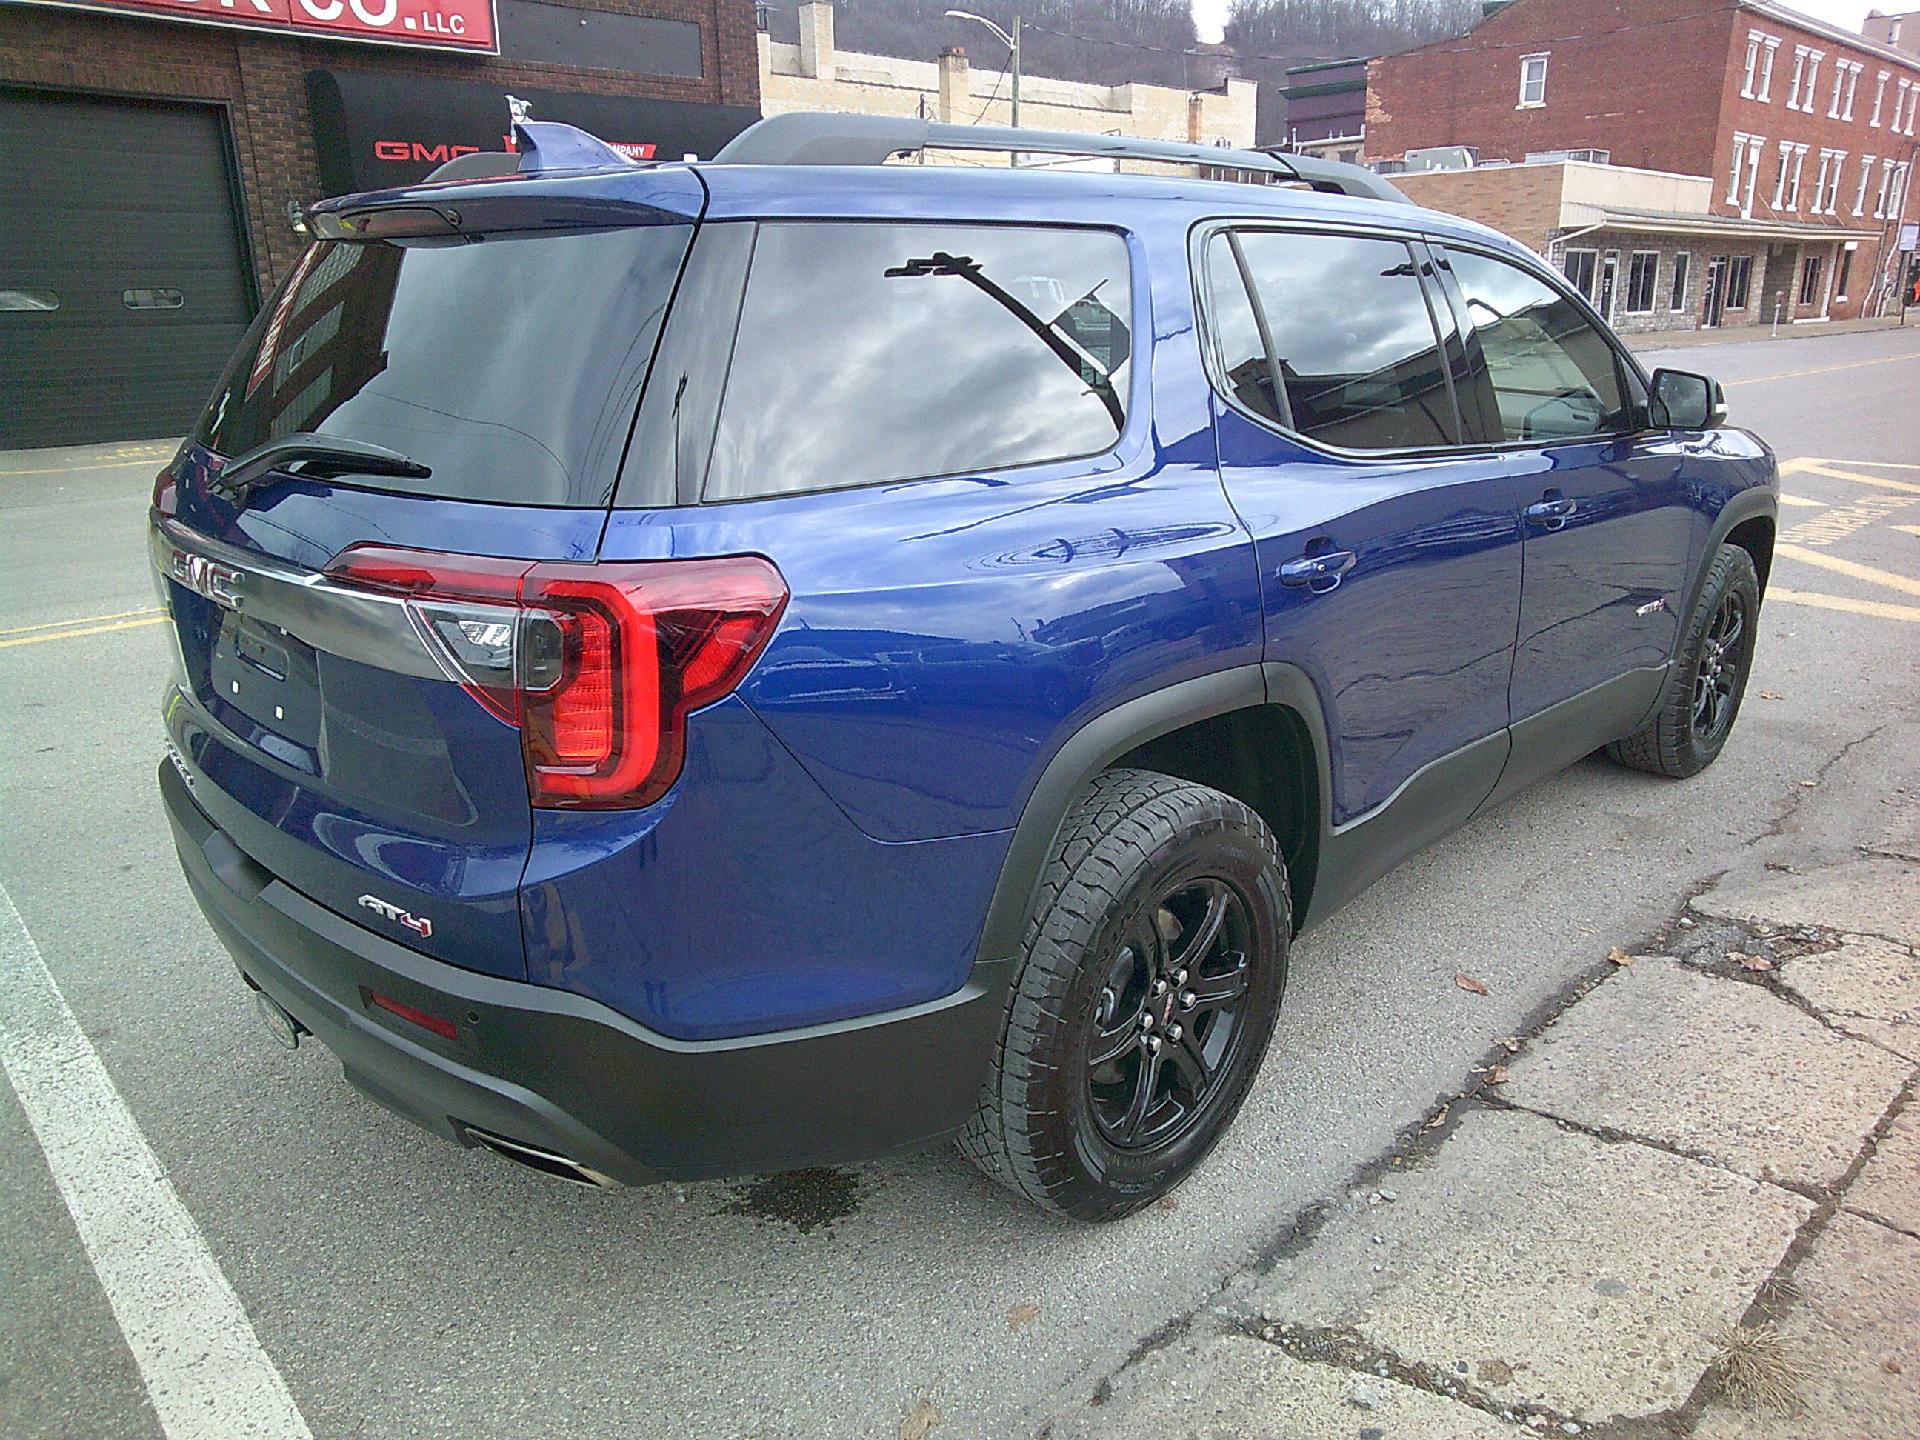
1210,230,1457,449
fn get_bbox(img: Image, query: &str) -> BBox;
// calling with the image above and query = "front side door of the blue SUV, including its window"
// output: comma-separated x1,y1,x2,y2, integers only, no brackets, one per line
1440,248,1703,787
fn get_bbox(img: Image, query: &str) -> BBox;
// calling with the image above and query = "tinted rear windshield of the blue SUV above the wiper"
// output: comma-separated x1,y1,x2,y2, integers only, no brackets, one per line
200,225,693,507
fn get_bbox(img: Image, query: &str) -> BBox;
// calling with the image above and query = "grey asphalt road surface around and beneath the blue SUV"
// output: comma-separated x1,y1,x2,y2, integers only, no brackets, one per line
0,330,1920,1440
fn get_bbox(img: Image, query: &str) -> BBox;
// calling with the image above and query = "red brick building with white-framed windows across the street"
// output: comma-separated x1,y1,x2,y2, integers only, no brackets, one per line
1367,0,1920,328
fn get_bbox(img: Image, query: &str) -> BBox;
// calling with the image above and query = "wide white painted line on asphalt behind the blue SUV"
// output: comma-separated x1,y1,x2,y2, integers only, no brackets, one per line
0,885,313,1440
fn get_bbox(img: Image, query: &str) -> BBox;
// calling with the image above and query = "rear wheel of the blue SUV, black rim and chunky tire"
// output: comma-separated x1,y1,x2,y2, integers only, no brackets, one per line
960,770,1292,1221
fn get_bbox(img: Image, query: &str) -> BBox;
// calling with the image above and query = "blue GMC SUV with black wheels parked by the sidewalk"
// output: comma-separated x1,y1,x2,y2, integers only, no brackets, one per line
150,115,1778,1219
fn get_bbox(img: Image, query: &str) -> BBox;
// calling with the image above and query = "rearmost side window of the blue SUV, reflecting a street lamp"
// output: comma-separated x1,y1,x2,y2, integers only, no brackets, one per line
705,223,1131,499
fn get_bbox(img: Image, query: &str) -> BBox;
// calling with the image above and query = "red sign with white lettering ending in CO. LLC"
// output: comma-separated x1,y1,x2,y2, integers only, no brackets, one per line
27,0,499,56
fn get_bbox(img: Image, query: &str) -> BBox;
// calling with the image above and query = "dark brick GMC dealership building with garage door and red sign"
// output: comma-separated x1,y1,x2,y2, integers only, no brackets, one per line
0,0,760,447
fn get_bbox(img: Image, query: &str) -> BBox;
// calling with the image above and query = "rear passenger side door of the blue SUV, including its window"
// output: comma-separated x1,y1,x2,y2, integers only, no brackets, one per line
1202,228,1521,833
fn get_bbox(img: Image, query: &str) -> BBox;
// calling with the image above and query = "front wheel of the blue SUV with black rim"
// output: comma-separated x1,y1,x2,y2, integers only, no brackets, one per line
1607,545,1761,780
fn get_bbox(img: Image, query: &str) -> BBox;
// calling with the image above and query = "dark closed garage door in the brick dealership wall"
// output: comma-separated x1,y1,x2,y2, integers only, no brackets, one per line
0,90,253,447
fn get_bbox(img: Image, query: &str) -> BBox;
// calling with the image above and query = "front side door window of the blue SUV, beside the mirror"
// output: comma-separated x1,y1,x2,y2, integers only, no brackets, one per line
1448,250,1626,442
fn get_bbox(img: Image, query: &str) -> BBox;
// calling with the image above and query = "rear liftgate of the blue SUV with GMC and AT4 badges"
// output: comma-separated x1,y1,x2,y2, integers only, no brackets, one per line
154,167,705,977
